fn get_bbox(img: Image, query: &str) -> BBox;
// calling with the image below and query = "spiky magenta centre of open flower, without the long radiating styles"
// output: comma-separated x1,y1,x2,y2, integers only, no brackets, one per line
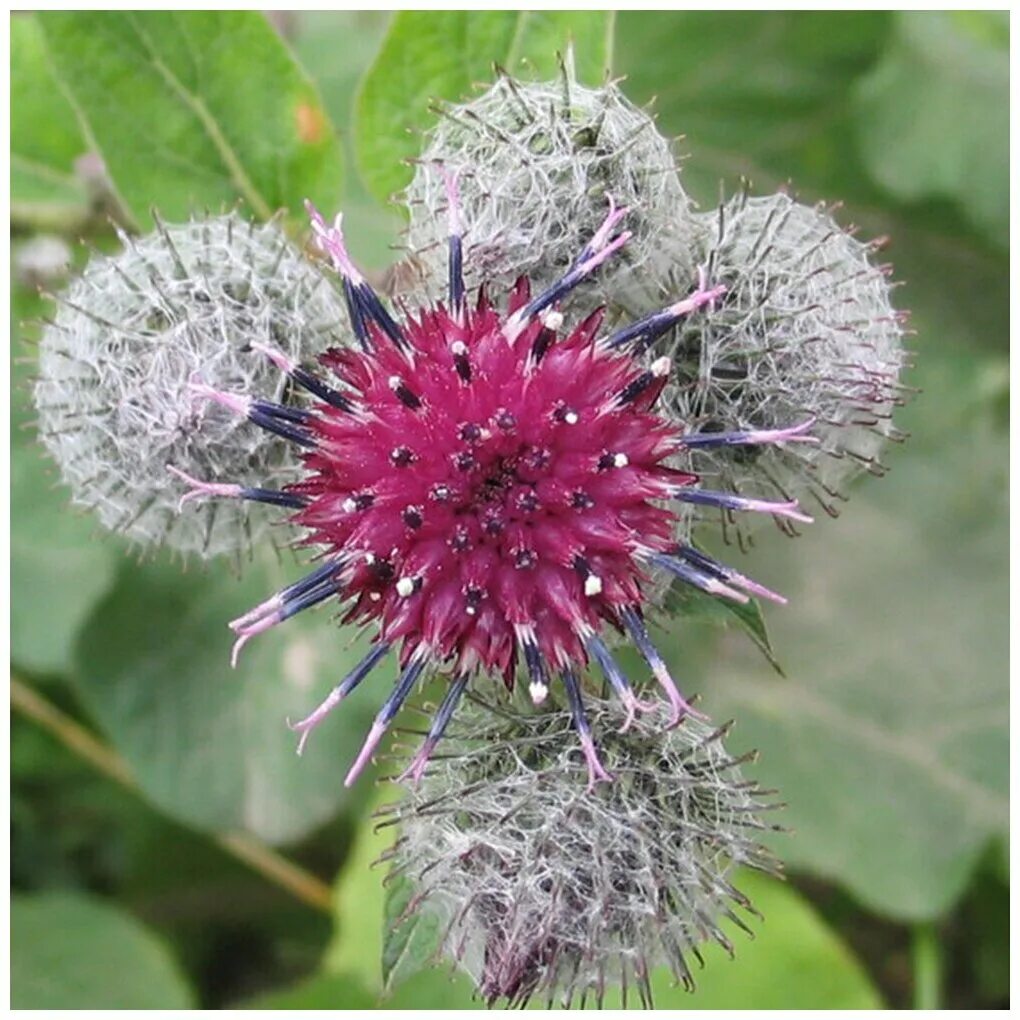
293,284,694,682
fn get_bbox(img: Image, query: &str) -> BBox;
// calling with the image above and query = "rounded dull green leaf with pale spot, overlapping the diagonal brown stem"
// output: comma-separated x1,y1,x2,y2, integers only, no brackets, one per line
75,562,383,843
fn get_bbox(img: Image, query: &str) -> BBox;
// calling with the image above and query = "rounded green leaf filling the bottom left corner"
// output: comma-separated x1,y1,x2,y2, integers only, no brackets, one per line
10,894,194,1010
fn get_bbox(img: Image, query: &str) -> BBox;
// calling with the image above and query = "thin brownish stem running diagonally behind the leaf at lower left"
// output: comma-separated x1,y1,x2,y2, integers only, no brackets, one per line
10,676,333,915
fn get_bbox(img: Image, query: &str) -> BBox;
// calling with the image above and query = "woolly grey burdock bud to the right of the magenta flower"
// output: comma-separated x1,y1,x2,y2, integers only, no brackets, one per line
656,193,907,542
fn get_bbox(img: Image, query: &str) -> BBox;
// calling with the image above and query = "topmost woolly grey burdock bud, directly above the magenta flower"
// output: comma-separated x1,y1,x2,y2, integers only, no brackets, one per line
404,58,704,315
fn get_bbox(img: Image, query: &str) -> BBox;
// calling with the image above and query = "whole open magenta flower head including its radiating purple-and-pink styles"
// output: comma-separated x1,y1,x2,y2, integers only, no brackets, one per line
171,174,811,784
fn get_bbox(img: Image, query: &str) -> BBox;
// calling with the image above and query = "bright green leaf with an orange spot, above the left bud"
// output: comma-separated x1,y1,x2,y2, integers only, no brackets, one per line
40,11,341,231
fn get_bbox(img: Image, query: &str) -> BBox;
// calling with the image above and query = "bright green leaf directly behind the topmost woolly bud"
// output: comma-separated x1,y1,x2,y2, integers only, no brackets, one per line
355,10,613,201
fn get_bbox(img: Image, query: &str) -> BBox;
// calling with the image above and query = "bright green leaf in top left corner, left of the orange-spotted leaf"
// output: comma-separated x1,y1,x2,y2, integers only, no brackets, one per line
10,13,89,231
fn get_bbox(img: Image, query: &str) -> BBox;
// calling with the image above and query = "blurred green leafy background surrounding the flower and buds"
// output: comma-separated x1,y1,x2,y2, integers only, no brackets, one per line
11,12,1009,1009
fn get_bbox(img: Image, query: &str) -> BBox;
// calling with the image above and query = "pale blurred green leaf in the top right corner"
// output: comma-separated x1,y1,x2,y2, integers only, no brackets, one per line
857,11,1010,248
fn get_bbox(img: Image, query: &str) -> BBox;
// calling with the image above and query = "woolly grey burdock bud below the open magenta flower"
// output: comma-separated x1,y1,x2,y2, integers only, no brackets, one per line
386,699,778,1007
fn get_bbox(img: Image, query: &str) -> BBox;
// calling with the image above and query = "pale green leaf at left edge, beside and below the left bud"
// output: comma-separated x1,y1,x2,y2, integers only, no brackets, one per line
10,275,122,675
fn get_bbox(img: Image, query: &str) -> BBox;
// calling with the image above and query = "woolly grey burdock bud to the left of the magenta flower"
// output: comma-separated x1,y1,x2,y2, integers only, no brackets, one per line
35,212,351,558
